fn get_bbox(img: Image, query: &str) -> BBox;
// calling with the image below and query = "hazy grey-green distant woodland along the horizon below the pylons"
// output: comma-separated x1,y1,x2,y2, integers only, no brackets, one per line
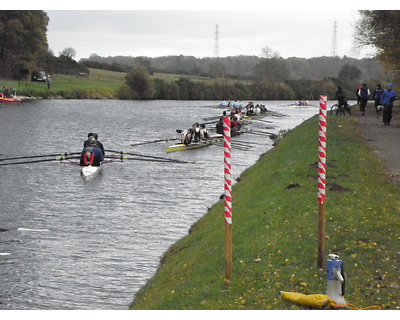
80,54,385,80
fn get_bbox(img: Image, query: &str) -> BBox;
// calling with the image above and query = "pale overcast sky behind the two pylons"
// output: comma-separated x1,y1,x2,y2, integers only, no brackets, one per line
7,0,398,60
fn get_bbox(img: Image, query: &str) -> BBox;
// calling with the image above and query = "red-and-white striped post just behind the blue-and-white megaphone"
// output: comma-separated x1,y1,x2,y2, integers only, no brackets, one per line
317,96,328,268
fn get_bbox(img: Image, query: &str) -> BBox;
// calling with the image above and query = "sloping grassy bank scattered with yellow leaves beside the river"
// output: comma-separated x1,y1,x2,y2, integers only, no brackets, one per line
131,117,400,310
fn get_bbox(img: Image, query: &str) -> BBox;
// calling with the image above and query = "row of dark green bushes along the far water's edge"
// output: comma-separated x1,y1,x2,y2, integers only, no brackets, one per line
118,66,372,101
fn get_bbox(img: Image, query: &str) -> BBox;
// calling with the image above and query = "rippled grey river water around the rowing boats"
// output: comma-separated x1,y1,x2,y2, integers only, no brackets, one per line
0,100,318,310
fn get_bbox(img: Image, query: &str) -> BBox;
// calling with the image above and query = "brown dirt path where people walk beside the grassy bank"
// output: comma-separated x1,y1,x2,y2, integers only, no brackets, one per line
352,105,400,188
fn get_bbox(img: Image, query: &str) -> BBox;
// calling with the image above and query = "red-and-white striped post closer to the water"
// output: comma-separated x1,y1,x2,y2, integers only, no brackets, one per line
224,117,232,281
